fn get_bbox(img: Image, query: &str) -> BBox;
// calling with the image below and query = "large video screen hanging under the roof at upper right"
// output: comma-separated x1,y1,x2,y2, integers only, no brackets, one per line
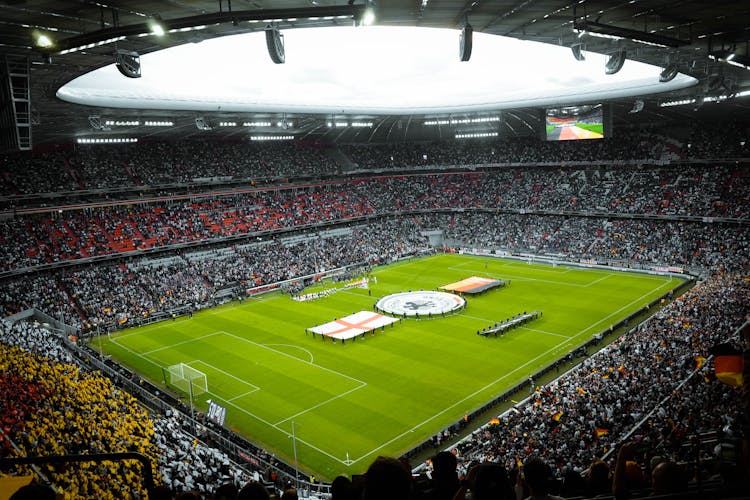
545,104,604,141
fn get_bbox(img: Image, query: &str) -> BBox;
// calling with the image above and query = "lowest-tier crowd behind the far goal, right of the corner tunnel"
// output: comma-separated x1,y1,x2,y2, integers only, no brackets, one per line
426,213,750,270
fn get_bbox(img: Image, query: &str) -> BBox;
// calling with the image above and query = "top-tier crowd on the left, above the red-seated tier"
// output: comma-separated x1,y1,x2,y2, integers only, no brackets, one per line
0,141,339,196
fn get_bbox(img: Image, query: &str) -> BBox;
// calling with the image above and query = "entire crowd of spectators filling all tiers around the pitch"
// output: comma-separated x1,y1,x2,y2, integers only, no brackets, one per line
0,131,750,498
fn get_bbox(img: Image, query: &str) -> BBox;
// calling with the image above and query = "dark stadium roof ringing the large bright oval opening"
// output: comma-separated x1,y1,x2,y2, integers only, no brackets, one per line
0,0,750,144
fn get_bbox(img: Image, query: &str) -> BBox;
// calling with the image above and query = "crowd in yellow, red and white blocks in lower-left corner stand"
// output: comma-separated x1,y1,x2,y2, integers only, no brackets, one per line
0,320,262,500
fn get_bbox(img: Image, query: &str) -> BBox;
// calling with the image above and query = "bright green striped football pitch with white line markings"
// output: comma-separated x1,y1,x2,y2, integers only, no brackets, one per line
102,255,682,480
